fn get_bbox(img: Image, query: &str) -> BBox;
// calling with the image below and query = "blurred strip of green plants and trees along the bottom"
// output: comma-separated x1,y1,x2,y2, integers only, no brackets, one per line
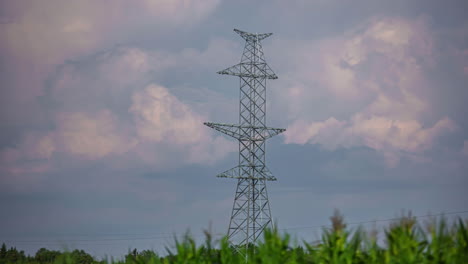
0,211,468,264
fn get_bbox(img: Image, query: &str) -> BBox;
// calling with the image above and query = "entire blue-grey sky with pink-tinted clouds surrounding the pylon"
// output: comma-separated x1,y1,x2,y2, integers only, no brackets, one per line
0,0,468,256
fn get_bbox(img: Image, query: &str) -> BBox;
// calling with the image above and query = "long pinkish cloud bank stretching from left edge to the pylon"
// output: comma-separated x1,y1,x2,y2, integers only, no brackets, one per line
0,81,235,186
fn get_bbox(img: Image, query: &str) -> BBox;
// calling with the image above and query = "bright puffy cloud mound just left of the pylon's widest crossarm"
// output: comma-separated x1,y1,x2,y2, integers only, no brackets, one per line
129,84,235,164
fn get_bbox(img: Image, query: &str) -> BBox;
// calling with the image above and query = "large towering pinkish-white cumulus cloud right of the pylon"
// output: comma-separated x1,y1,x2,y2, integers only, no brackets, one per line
285,18,456,166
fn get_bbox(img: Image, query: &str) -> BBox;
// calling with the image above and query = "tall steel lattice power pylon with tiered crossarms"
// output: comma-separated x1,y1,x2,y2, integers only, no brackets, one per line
204,29,285,250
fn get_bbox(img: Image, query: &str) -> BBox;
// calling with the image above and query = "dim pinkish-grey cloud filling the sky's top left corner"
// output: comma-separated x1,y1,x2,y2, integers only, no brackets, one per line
0,0,219,64
